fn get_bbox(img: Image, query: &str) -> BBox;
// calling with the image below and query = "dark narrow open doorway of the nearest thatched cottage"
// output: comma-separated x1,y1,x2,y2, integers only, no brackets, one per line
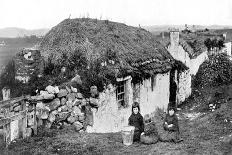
168,69,177,109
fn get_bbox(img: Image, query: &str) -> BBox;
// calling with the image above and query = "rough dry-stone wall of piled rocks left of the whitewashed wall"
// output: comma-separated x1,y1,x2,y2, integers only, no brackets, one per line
33,85,98,131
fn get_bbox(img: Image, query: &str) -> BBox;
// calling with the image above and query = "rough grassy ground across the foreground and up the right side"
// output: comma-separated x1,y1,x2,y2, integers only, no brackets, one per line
0,86,232,155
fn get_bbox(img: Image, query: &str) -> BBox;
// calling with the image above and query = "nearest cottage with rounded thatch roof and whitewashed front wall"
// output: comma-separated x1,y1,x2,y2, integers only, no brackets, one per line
40,18,188,132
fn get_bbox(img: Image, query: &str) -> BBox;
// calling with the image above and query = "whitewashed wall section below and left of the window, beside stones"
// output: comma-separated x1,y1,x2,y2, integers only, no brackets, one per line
87,78,133,133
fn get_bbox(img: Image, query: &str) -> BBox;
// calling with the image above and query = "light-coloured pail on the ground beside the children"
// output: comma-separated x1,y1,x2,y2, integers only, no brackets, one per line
121,126,135,146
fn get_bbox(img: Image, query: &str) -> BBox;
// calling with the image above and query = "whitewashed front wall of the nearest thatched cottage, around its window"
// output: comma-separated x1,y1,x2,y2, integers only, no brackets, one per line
87,72,170,133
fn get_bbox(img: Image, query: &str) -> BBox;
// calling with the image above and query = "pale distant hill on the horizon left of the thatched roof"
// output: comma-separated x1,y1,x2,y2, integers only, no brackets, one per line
0,27,49,38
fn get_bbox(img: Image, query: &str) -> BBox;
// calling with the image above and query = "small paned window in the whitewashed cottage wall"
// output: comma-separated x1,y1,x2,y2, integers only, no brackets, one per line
116,81,125,107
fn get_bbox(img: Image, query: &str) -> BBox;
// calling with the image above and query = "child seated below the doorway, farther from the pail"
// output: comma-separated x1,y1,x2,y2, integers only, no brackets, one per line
163,107,182,143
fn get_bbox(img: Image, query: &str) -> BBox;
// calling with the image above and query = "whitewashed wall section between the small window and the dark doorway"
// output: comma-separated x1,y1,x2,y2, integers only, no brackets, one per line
134,72,170,116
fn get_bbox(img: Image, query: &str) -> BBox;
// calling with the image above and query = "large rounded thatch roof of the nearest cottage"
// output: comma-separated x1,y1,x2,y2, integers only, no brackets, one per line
40,18,174,77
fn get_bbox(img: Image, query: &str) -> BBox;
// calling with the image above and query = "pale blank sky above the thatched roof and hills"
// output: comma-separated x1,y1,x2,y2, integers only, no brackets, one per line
0,0,232,29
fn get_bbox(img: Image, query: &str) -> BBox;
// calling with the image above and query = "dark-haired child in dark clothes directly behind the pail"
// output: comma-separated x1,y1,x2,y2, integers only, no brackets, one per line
129,102,144,142
